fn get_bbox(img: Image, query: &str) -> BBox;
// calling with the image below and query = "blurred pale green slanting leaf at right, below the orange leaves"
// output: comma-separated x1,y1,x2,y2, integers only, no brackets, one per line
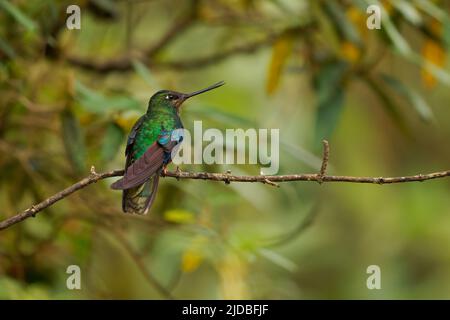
381,74,434,121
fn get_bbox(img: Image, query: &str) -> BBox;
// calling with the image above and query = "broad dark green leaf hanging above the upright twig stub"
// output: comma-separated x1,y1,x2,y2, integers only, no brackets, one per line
314,62,347,139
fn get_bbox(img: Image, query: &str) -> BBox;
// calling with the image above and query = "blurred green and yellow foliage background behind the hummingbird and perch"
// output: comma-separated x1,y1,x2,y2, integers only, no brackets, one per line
0,0,450,299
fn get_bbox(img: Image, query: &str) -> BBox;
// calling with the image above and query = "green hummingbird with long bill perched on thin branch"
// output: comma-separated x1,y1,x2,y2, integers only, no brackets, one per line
111,81,224,214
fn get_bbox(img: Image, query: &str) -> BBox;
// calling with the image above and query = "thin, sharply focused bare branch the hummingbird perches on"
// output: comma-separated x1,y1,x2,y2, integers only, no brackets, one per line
0,140,450,230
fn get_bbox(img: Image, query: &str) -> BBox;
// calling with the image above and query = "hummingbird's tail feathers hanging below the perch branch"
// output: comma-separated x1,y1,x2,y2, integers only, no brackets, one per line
122,173,159,214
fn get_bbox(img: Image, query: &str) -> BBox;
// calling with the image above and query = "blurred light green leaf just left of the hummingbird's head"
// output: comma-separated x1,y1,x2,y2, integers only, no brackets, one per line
75,81,142,113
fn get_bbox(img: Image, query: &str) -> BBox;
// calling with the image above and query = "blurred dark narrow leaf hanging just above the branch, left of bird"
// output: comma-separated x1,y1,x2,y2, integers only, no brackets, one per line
61,109,86,174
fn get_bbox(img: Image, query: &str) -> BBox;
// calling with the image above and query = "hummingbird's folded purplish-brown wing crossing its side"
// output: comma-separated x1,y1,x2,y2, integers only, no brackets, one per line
111,142,166,190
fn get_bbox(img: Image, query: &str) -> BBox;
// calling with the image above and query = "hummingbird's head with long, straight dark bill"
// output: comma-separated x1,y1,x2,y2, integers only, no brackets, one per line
148,81,225,112
